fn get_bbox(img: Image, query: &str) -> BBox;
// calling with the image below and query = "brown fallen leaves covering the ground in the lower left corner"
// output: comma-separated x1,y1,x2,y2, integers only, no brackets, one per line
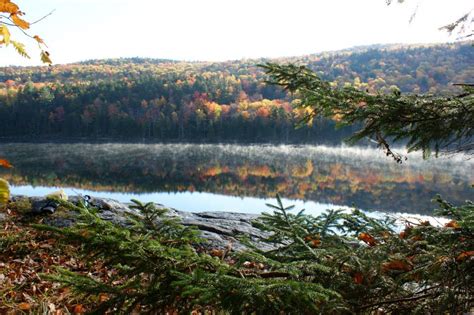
0,204,108,315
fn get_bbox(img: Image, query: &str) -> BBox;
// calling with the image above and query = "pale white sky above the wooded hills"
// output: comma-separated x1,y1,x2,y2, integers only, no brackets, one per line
0,0,474,66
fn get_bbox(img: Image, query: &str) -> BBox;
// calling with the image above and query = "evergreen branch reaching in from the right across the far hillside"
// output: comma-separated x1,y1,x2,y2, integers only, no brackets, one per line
262,63,474,162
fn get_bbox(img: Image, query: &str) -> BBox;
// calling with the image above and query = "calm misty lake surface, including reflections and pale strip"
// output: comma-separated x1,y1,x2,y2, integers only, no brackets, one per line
0,143,474,214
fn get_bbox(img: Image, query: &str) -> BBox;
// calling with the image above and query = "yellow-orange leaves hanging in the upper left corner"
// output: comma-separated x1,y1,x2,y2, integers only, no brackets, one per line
0,0,52,64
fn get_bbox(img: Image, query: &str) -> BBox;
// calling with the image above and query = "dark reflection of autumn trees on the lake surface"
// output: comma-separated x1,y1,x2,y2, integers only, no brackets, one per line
0,144,472,212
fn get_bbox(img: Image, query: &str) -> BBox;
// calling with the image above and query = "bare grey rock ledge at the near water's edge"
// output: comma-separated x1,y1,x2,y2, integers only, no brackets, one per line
12,196,274,251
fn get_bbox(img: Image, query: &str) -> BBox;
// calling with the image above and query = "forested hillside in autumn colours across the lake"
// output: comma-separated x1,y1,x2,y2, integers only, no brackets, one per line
0,42,474,143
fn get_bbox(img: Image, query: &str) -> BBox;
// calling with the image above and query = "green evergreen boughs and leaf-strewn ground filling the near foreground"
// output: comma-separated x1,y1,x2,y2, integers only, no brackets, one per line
0,198,474,314
